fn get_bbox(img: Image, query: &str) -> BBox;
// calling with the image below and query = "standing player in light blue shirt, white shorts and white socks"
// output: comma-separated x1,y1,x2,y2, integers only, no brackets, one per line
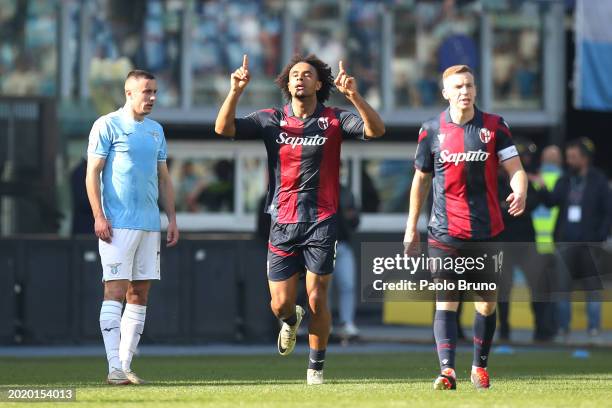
85,70,179,384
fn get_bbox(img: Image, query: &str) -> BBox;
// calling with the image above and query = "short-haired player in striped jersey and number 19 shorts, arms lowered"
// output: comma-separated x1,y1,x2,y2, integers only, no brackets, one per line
404,65,527,390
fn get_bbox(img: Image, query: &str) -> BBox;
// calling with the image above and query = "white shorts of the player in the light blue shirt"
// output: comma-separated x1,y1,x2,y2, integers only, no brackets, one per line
98,228,161,281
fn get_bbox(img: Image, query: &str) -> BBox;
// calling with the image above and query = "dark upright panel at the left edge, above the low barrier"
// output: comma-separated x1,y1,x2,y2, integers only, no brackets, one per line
0,96,62,234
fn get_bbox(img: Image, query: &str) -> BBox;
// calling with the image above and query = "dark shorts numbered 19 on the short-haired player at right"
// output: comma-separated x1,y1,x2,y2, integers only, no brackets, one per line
428,237,500,292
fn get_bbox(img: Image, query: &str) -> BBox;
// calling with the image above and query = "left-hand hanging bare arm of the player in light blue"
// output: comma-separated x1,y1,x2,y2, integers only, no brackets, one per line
85,154,113,243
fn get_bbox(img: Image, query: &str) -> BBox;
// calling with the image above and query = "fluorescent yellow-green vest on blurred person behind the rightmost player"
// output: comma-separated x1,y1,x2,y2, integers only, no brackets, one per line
531,171,561,254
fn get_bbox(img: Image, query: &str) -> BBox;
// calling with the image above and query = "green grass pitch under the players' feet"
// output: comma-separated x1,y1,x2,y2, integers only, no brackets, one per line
0,350,612,408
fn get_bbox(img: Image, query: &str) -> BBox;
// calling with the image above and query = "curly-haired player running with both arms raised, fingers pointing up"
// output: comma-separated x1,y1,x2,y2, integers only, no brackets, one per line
215,55,385,384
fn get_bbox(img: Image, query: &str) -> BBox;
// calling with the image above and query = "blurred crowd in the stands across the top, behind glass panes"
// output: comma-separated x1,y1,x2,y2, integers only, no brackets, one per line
0,0,543,112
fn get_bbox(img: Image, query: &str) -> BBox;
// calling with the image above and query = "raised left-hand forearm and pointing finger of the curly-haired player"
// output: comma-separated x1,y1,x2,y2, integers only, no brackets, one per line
215,54,251,137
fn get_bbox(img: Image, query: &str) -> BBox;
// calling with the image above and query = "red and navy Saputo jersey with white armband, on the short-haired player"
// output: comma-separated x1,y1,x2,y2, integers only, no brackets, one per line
415,108,518,243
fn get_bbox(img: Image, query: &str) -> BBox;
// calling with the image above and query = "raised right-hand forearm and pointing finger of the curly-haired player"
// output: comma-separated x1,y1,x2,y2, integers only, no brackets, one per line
334,61,385,138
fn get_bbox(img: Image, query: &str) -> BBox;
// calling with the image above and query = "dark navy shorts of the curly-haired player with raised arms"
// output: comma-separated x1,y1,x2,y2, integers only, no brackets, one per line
268,216,338,281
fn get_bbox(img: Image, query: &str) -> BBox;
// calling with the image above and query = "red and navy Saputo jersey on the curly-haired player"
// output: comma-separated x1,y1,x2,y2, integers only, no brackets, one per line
235,104,365,224
